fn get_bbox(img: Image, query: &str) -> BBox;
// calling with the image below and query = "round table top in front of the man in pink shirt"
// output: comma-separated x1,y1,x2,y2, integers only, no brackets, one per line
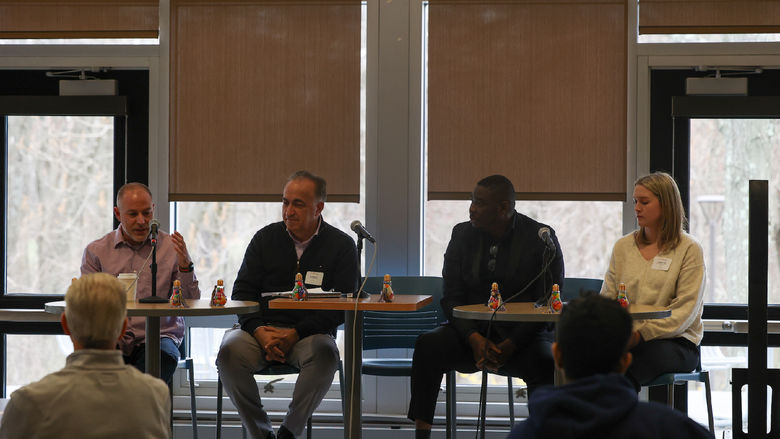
45,299,260,317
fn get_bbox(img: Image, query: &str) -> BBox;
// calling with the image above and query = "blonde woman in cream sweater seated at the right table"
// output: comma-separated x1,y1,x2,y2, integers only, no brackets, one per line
601,172,705,390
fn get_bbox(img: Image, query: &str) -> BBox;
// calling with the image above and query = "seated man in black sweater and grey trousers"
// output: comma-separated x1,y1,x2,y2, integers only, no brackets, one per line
217,171,359,439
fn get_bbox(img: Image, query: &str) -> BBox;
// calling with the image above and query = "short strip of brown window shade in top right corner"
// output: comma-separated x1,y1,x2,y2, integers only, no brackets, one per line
639,0,780,34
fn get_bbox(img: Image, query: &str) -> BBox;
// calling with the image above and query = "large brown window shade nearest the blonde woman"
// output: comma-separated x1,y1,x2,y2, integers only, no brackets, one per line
428,0,627,200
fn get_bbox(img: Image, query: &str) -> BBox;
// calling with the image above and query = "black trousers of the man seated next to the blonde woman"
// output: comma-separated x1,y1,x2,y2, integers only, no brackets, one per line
408,326,554,424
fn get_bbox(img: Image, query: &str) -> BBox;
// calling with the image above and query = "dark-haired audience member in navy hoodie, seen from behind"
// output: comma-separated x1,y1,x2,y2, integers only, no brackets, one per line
507,295,714,439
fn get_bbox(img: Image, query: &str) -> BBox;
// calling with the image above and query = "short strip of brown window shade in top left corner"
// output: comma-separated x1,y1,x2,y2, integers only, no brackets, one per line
0,0,159,39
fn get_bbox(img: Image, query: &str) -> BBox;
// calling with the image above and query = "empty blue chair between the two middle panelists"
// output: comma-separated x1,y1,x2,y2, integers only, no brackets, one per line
361,276,464,439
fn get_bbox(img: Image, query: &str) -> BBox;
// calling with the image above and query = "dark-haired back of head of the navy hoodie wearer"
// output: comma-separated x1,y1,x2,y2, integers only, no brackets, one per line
555,295,632,380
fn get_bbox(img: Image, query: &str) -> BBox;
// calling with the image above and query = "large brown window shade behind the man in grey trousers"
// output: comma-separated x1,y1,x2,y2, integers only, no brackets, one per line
169,0,361,202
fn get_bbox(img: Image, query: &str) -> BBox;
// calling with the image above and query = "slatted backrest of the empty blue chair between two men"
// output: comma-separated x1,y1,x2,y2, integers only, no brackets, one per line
363,276,444,350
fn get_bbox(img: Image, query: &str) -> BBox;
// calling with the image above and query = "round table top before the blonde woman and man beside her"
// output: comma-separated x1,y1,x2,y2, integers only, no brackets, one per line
452,302,672,322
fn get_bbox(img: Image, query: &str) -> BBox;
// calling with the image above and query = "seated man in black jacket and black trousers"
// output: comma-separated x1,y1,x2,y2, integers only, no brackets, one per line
408,175,564,438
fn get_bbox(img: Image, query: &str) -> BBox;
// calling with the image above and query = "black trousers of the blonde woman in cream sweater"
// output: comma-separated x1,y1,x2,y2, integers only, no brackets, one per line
626,337,699,391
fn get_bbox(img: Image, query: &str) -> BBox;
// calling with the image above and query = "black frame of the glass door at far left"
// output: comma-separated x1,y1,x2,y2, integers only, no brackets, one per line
0,69,151,397
